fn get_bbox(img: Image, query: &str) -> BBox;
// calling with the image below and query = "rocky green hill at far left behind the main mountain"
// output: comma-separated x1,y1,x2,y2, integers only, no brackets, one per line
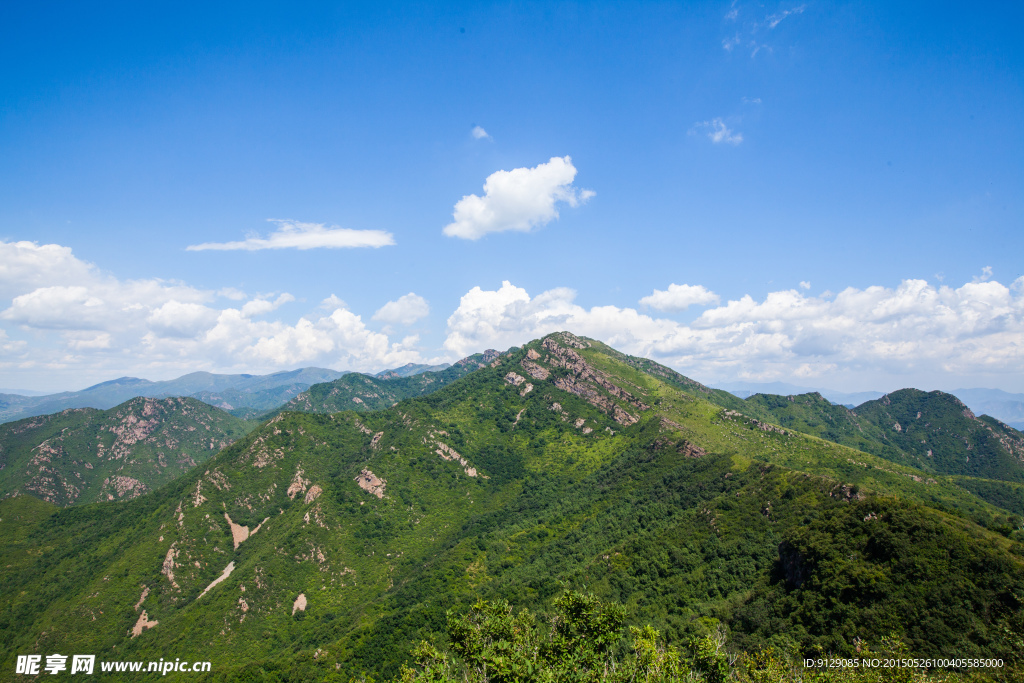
0,398,255,506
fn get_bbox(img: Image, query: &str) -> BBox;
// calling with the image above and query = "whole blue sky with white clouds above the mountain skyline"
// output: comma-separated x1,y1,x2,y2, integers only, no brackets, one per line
0,1,1024,391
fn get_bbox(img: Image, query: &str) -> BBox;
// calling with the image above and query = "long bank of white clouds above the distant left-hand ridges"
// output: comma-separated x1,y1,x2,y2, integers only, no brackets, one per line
0,243,426,386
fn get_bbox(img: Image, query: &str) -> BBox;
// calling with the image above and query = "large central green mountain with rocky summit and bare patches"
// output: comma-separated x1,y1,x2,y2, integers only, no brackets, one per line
0,333,1024,681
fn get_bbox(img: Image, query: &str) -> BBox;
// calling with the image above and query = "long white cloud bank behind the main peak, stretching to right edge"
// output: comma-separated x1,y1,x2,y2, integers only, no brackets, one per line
444,279,1024,388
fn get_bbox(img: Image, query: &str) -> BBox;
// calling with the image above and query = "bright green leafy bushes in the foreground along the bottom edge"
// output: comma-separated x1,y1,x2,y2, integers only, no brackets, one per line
401,591,1020,683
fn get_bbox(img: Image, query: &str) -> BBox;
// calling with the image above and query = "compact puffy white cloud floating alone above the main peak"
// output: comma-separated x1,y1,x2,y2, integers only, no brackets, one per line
443,157,594,240
